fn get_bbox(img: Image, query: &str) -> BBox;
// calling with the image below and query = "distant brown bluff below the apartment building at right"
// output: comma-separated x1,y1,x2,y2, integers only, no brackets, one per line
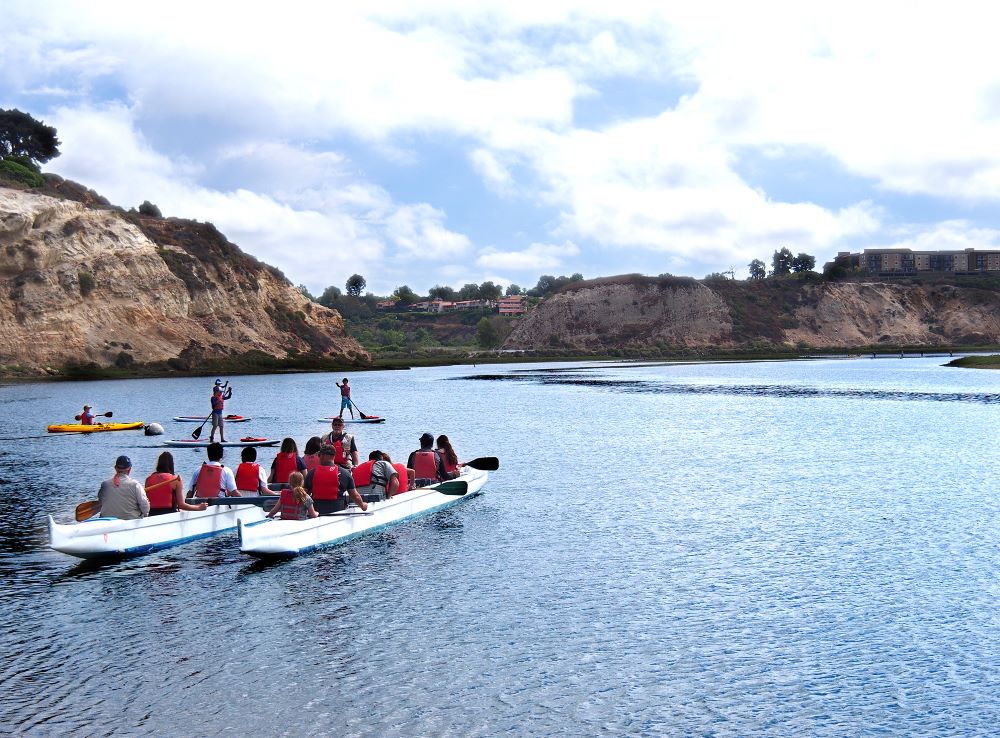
503,275,1000,353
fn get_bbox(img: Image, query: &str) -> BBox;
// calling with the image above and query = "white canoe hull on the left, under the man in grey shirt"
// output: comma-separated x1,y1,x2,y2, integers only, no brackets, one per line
49,505,264,559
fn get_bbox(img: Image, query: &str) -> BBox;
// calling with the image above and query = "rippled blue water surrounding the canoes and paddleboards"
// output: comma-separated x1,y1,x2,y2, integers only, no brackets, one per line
0,358,1000,736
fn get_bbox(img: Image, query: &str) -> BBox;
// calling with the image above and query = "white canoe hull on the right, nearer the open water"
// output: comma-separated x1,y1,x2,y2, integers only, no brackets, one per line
239,469,489,557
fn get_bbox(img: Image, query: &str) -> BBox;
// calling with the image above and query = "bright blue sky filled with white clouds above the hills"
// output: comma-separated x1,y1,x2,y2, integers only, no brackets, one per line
0,0,1000,295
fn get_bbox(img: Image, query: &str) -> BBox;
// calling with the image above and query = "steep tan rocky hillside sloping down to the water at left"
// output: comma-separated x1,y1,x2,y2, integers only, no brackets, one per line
0,176,370,375
